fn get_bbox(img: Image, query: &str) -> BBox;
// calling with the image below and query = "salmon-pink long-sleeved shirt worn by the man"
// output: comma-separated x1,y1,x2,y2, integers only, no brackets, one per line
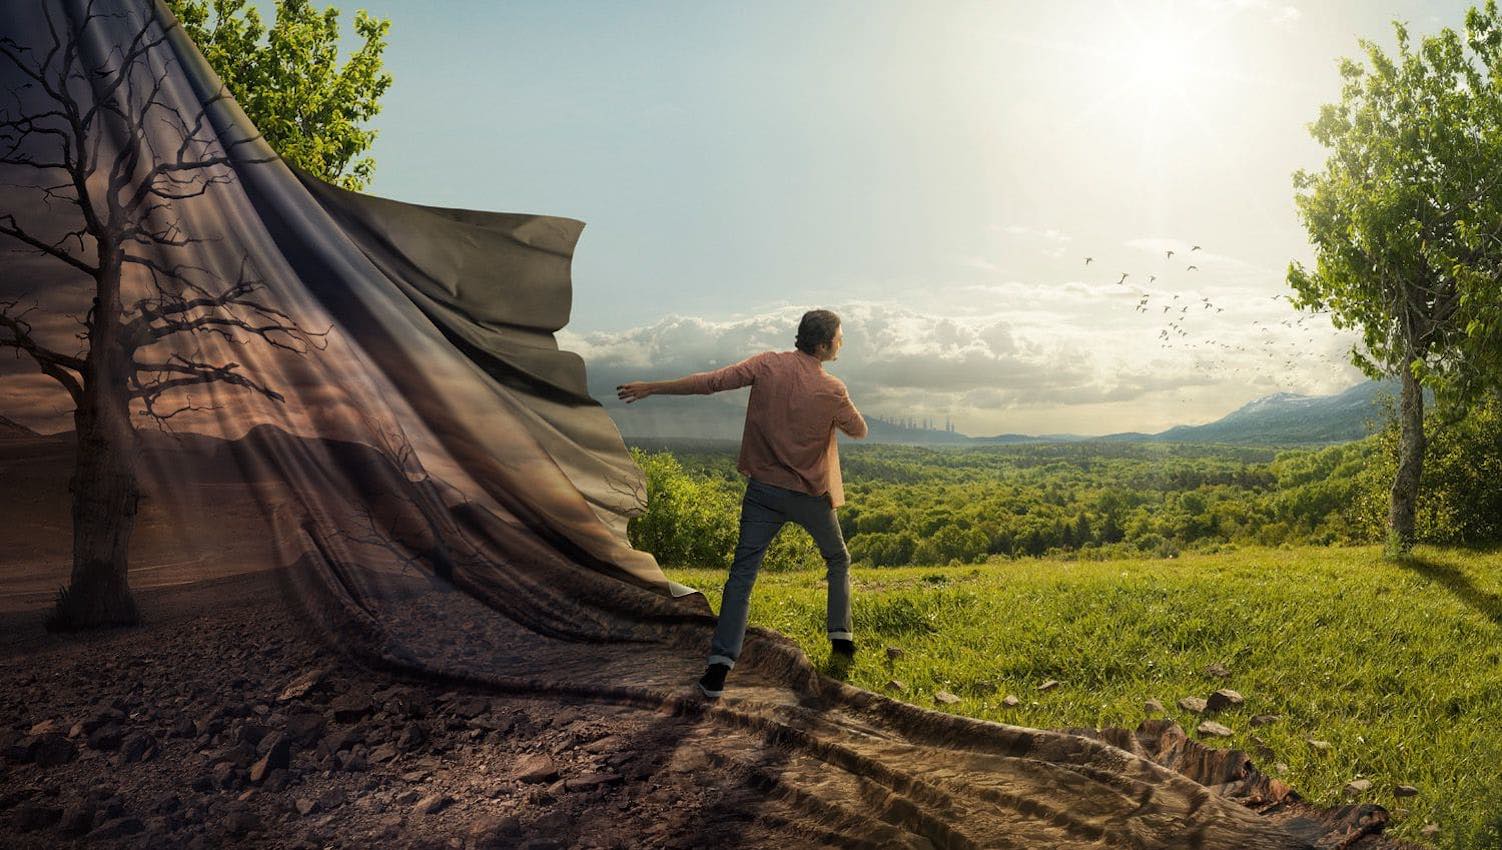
685,348,867,508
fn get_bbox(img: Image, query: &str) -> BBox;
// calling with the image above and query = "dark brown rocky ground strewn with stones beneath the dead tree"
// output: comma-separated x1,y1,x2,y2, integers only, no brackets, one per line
0,577,838,850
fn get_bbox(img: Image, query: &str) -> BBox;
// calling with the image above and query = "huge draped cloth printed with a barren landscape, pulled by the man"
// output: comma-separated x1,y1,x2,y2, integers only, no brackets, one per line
0,0,1405,848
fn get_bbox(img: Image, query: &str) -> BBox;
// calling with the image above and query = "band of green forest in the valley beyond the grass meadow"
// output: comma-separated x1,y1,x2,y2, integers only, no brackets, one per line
621,429,1502,569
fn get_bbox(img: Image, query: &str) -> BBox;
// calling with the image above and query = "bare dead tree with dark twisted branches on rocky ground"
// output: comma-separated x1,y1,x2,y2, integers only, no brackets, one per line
0,3,327,629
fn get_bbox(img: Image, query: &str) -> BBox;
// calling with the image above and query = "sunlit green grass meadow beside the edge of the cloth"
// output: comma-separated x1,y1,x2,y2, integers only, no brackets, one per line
667,547,1502,850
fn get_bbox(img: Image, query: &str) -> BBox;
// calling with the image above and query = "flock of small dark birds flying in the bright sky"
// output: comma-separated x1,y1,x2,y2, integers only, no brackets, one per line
1084,245,1344,381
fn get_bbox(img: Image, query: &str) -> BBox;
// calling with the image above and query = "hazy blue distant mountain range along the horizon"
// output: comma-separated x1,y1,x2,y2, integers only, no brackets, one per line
594,380,1405,446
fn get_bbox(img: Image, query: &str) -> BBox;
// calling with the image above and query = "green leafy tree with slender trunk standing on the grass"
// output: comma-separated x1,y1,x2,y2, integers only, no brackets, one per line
1287,0,1502,554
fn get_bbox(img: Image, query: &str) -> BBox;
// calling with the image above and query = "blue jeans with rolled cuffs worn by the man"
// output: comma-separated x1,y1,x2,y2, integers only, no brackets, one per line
709,478,850,667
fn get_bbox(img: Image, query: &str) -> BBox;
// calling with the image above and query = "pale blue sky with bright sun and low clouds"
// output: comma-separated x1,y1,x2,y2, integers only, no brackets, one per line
283,0,1469,434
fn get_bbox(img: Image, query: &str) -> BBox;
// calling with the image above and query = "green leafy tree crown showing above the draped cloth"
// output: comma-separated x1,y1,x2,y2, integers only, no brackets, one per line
167,0,392,189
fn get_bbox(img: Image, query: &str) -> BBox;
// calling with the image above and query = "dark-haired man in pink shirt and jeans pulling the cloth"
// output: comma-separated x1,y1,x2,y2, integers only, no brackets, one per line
616,309,867,698
